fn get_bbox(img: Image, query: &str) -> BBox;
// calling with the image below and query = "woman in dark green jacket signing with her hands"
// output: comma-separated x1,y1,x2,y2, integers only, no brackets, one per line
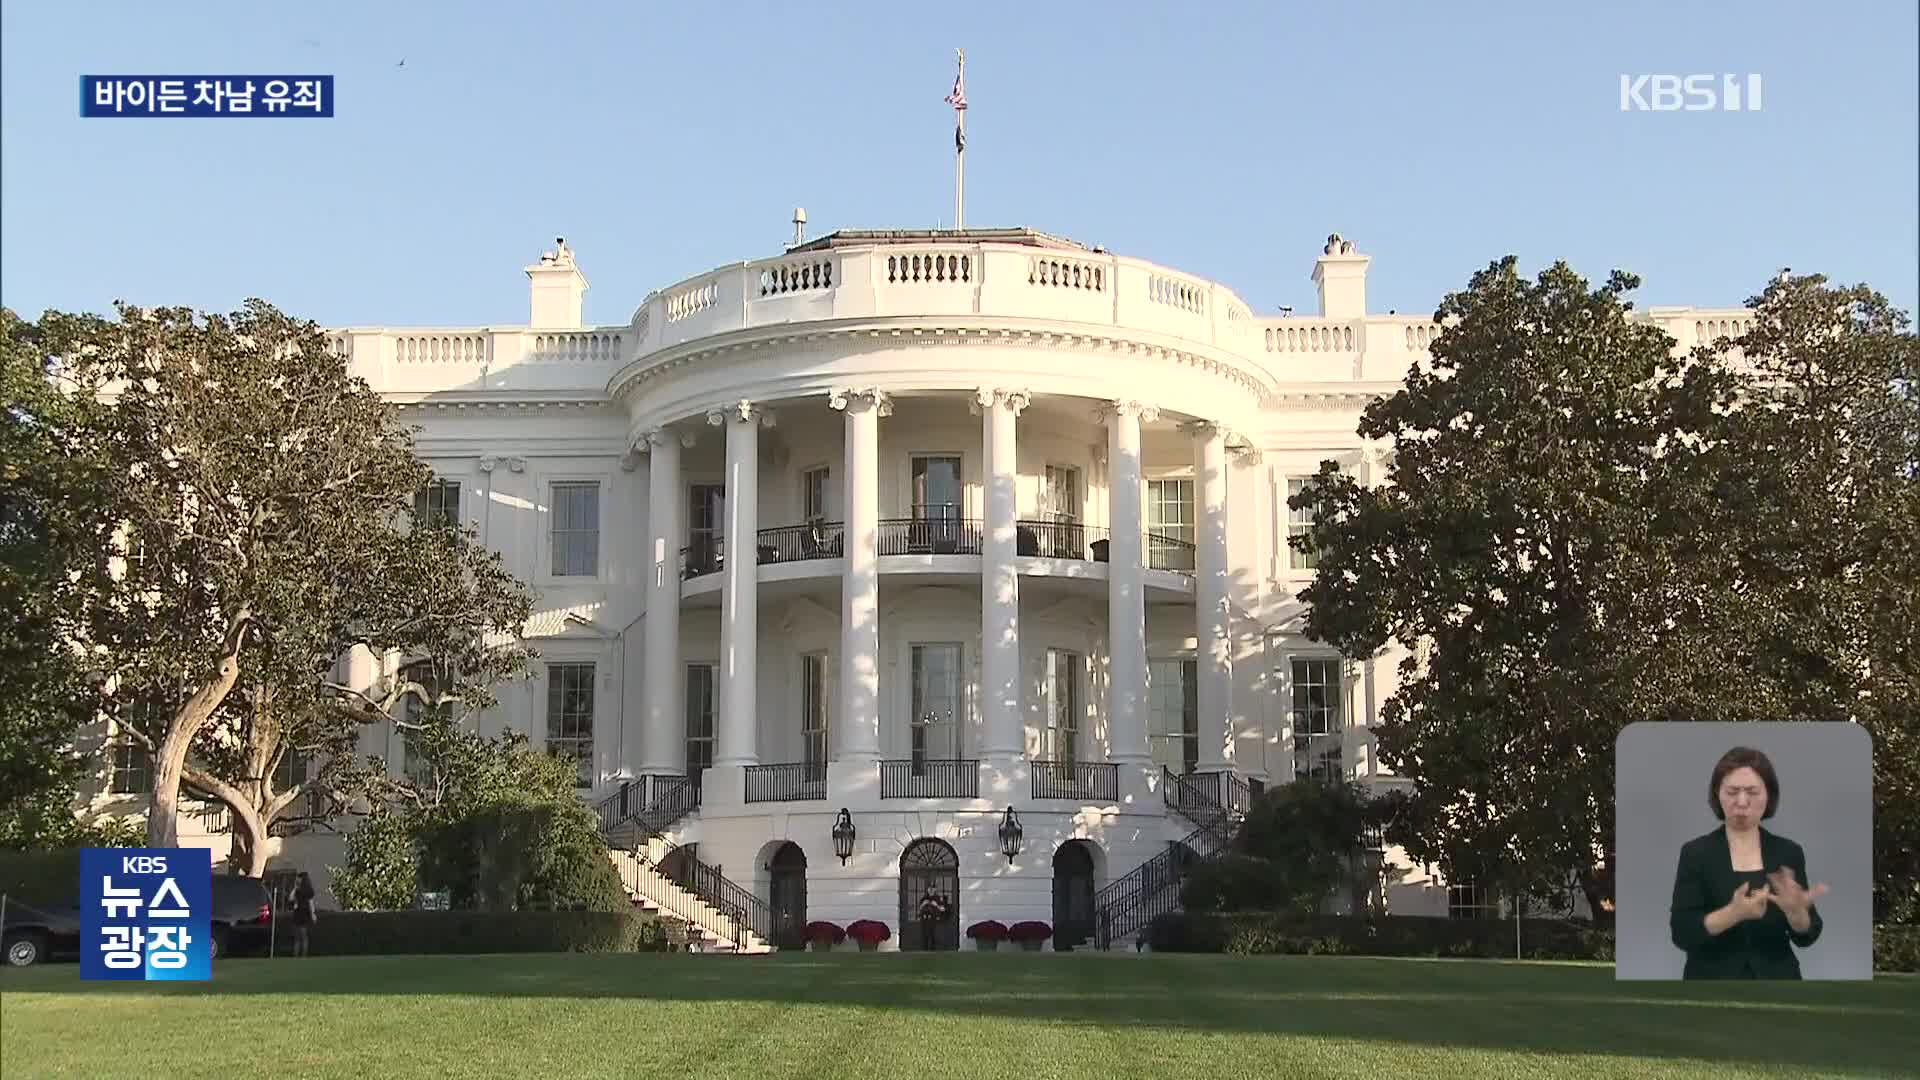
1670,748,1826,978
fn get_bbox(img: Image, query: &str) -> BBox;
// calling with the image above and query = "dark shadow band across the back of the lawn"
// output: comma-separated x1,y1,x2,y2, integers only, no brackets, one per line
0,953,1920,1072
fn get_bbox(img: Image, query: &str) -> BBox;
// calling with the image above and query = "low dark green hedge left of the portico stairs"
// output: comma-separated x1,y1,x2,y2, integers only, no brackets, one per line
263,911,666,957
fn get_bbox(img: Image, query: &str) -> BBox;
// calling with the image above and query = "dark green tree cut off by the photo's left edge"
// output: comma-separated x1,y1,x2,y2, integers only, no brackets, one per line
0,309,111,847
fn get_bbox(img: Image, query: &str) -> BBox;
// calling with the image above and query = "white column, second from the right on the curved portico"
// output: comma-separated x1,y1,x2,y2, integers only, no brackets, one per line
1104,402,1158,765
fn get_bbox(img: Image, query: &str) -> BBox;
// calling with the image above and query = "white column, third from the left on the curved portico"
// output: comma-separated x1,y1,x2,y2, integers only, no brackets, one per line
828,390,893,763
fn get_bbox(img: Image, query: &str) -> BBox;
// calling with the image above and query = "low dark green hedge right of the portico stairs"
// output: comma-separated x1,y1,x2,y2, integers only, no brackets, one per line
1148,911,1613,961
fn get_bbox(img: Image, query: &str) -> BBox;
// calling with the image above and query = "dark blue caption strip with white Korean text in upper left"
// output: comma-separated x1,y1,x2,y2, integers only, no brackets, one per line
81,75,334,117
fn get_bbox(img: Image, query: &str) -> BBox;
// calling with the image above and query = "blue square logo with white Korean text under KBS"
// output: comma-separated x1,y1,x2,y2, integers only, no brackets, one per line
81,847,213,982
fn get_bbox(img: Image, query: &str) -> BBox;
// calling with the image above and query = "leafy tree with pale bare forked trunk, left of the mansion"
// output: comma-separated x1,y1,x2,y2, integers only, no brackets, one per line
22,300,530,853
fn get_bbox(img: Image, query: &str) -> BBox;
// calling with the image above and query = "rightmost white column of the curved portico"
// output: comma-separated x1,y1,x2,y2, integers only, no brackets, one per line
1187,423,1233,773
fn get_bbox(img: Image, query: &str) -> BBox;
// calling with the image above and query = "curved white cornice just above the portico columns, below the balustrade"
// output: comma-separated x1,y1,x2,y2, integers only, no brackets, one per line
607,323,1275,402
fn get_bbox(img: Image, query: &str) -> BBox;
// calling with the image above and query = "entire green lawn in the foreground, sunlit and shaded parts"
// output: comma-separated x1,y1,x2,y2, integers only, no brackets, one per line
0,953,1920,1080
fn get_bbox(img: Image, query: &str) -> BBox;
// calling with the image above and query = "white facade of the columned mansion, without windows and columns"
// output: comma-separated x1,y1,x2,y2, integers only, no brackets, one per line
82,231,1720,922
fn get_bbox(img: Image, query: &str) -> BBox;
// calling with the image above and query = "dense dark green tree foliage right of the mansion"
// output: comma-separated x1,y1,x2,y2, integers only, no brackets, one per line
1292,258,1920,919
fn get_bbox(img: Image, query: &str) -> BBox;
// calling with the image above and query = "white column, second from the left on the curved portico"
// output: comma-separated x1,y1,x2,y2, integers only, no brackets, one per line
707,402,772,767
